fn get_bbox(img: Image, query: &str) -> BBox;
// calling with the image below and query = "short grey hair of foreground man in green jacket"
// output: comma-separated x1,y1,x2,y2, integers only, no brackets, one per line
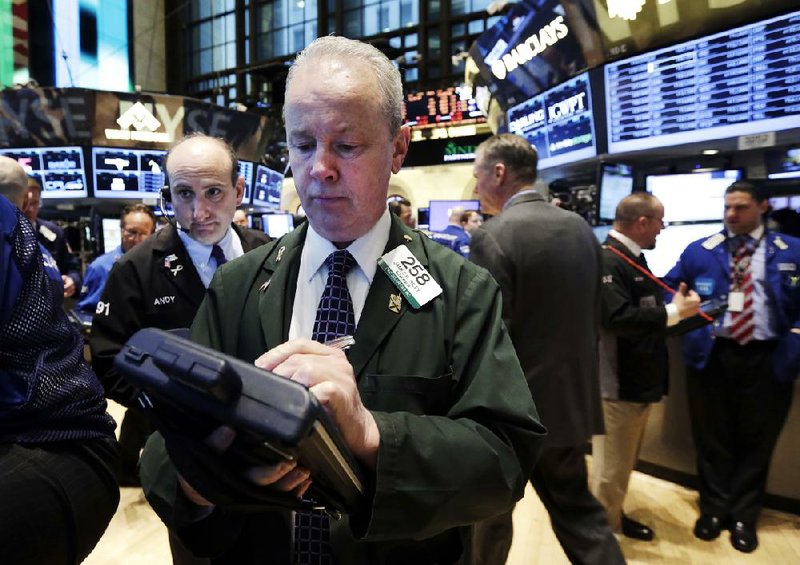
284,35,403,135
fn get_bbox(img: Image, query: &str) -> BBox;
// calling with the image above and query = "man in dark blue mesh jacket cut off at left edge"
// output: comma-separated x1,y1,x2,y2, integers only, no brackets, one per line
0,157,119,565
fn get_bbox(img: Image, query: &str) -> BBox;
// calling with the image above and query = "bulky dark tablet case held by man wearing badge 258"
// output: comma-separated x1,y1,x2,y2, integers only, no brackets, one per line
114,328,365,513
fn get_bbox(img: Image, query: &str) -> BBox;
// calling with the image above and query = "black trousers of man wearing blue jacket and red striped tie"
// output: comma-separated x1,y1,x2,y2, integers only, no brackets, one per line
686,338,793,524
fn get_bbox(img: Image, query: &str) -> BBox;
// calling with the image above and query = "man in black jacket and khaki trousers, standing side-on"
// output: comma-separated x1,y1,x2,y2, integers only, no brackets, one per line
590,192,700,540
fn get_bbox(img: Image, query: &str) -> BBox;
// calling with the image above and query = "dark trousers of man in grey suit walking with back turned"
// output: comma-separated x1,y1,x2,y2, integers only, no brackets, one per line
473,446,625,565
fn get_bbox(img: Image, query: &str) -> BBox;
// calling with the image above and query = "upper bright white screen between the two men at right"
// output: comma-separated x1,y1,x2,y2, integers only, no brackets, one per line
645,170,742,222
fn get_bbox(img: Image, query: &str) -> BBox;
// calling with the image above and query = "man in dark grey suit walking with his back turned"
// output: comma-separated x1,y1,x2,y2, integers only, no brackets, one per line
470,134,624,565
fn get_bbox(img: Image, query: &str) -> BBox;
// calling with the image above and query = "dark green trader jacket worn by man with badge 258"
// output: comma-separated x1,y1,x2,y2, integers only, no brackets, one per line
141,217,546,565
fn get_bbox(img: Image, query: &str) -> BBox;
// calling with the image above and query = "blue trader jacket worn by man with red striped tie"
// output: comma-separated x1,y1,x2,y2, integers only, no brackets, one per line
664,230,800,382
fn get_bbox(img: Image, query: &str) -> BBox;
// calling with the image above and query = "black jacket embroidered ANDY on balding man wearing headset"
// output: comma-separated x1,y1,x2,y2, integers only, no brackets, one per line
89,221,270,406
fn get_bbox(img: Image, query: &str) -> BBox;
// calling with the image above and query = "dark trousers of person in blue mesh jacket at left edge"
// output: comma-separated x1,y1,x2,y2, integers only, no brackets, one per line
0,439,119,565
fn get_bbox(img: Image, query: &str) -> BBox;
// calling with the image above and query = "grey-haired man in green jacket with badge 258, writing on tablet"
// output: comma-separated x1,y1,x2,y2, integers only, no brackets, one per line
141,37,545,565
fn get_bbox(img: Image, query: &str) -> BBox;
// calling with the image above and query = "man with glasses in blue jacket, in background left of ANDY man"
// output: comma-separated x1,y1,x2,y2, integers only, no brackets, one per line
78,203,156,312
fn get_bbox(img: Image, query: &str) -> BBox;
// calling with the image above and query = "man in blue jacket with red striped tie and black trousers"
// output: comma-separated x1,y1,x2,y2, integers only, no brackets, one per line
665,182,800,553
